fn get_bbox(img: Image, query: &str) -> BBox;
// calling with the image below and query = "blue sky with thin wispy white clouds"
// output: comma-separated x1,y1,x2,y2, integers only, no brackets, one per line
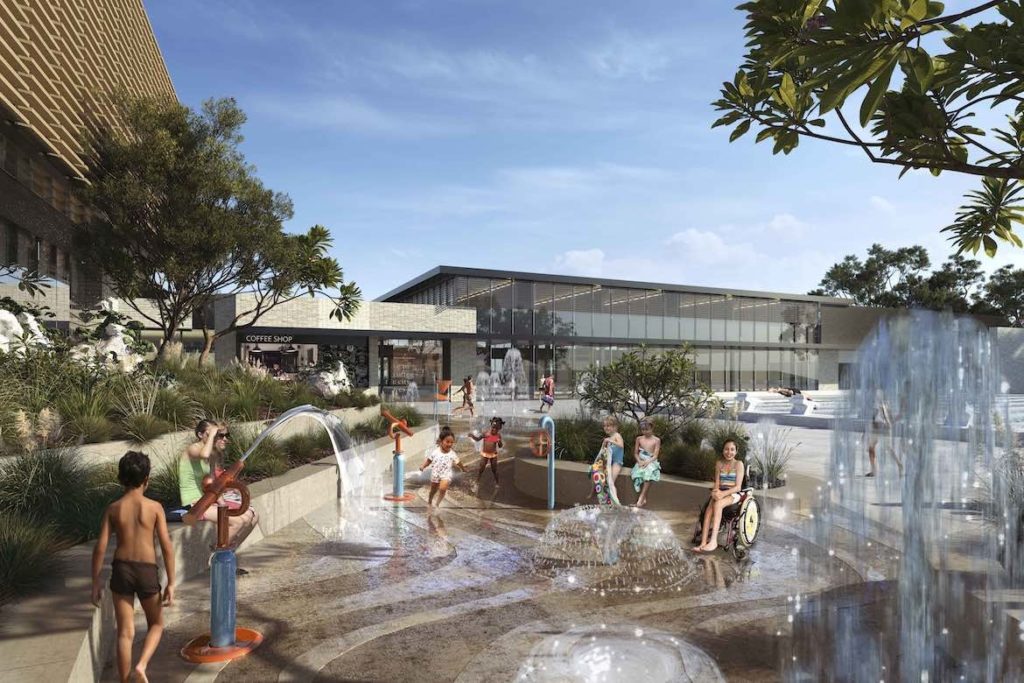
145,0,1024,298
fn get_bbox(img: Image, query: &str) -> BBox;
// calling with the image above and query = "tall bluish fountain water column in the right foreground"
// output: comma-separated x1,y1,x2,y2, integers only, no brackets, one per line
786,312,1022,682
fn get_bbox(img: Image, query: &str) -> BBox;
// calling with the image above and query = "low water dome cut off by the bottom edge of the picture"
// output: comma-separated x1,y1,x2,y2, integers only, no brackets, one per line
515,624,725,683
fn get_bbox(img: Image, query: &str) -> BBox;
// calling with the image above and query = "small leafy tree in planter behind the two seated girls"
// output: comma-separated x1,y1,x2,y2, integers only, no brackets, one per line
579,345,722,431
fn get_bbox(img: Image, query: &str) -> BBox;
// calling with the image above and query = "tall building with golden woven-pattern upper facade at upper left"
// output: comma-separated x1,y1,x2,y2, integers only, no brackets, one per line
0,0,174,307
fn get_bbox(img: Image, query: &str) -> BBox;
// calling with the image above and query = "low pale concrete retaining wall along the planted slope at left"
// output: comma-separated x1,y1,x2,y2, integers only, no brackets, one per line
0,421,433,683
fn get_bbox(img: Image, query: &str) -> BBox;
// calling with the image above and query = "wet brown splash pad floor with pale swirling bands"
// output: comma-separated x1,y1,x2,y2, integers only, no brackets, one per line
106,432,891,683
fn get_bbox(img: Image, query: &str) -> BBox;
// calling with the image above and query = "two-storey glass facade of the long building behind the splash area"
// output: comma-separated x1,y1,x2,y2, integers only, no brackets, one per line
391,275,821,394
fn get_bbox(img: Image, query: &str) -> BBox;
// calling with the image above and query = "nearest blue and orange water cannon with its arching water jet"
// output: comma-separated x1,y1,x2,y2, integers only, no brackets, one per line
181,405,366,664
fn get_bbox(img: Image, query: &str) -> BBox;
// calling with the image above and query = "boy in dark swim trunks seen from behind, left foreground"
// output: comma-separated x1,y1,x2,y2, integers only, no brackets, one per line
92,451,174,681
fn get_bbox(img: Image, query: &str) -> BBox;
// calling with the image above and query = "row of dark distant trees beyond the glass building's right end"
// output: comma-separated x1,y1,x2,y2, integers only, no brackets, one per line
810,244,1024,326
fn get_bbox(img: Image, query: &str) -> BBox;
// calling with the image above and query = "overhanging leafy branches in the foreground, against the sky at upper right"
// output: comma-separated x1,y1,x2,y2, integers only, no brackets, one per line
714,0,1024,256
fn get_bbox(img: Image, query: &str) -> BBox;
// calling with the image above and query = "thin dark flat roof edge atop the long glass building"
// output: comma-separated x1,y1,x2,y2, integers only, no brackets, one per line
375,265,853,306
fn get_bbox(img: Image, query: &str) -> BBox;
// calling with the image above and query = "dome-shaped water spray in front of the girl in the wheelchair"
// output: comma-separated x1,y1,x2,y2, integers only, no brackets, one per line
534,505,697,595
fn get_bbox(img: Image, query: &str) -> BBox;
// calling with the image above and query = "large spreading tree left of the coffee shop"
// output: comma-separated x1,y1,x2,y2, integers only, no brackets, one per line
76,98,359,356
